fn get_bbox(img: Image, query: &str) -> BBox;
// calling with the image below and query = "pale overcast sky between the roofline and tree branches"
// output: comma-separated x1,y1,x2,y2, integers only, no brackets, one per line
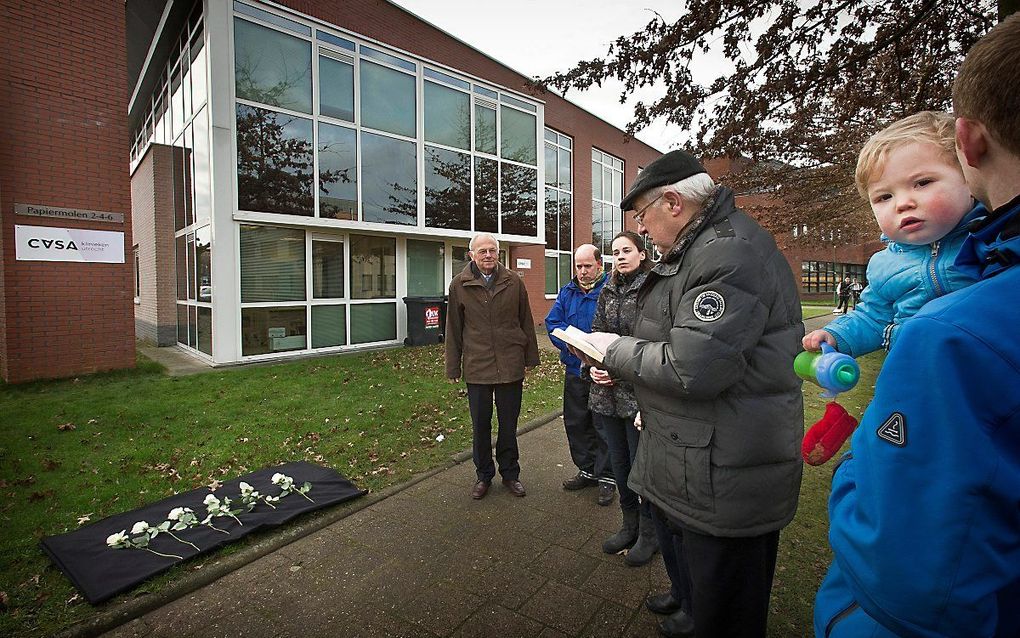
390,0,686,151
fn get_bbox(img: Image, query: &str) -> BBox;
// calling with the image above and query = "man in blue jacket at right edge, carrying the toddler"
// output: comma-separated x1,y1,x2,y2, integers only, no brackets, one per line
815,14,1020,637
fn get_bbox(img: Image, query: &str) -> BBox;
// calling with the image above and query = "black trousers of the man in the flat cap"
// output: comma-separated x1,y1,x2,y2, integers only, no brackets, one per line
652,506,779,638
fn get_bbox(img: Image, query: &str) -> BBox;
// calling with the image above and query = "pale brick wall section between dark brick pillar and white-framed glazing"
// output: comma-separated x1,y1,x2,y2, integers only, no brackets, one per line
131,144,177,346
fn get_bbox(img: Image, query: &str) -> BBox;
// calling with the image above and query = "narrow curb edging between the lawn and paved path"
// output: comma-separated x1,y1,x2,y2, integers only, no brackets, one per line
57,410,563,638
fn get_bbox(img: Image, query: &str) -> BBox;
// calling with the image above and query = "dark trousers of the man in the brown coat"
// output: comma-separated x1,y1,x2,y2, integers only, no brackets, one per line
467,379,524,482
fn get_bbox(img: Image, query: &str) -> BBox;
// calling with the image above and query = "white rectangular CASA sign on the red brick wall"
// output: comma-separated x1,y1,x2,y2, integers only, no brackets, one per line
14,225,124,263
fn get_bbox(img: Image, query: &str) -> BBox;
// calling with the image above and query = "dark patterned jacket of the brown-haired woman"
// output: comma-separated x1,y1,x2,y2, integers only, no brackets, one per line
588,271,648,419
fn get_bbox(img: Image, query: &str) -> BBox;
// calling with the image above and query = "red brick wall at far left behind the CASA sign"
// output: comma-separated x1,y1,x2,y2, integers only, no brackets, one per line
0,0,135,382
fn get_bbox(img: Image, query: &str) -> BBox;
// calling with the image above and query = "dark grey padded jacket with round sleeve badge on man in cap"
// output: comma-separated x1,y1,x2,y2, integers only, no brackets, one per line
605,187,804,537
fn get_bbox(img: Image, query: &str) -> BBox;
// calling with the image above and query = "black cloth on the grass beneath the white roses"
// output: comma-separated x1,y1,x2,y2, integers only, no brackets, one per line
42,461,366,604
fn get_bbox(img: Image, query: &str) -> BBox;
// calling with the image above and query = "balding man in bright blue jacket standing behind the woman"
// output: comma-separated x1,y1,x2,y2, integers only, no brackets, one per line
546,244,616,505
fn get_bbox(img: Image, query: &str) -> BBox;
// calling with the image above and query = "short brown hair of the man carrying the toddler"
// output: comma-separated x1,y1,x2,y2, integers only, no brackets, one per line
953,13,1020,155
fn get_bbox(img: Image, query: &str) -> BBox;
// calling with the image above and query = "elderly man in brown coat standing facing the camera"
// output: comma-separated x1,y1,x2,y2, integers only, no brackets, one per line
446,233,539,499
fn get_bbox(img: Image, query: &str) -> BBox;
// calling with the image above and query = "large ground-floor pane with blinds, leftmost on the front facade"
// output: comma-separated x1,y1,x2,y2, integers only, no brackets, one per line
241,224,305,302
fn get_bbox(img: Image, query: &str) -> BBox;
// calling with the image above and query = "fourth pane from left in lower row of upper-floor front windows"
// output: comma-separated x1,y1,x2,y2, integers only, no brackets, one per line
425,146,471,231
